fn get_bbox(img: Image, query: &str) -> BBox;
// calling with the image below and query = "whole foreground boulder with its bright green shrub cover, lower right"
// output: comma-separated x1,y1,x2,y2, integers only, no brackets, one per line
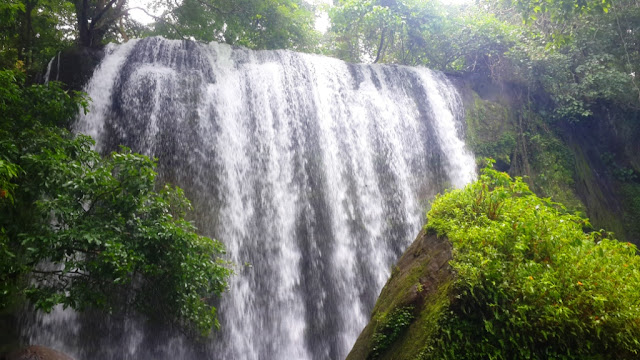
348,167,640,360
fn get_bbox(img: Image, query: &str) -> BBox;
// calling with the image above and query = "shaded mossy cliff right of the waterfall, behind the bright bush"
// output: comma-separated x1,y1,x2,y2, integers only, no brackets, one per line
449,74,640,245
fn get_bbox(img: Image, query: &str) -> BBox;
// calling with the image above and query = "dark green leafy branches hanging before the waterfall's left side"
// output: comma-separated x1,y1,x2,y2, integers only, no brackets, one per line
0,71,230,333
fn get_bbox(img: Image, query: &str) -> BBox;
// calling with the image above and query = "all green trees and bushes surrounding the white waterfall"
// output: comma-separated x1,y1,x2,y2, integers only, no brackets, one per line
0,0,640,359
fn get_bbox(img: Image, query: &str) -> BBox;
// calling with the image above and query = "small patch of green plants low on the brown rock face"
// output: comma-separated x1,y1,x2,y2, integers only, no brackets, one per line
369,306,415,359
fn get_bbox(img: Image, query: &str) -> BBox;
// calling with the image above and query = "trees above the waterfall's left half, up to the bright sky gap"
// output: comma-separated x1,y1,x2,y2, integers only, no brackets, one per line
0,0,320,75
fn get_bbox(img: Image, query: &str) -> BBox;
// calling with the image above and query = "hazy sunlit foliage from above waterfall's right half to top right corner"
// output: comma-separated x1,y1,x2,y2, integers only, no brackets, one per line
328,0,640,121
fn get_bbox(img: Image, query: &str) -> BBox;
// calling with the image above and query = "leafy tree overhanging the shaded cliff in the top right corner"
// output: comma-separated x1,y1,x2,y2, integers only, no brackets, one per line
487,0,640,122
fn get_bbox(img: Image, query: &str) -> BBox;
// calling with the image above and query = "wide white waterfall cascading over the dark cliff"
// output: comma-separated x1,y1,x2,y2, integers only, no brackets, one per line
21,38,475,359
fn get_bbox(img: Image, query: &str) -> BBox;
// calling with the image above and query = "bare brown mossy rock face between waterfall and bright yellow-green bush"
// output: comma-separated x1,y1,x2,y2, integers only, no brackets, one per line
347,230,454,360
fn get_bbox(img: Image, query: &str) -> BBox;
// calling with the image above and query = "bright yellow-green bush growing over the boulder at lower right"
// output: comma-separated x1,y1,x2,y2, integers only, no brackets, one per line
423,161,640,359
